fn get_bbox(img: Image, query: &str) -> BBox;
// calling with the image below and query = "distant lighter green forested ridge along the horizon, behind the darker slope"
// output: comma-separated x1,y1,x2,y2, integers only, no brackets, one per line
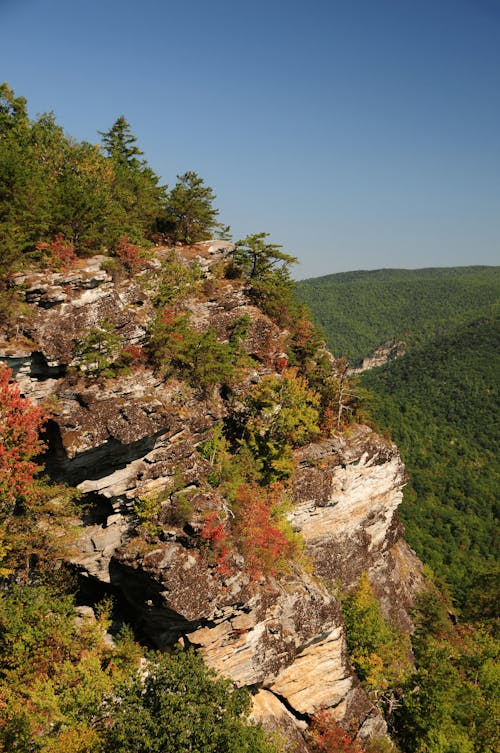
297,267,500,365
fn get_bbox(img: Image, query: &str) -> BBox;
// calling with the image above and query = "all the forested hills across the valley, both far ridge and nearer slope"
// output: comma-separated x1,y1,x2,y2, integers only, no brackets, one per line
298,267,500,616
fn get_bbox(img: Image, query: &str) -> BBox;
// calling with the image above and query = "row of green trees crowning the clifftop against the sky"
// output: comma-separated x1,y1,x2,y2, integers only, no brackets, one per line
0,84,223,280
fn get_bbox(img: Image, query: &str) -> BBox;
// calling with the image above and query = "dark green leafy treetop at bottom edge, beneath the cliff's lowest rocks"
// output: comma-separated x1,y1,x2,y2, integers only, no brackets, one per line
104,651,273,753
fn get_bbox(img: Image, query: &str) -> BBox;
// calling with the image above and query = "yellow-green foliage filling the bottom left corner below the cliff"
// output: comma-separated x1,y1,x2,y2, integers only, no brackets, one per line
0,585,138,753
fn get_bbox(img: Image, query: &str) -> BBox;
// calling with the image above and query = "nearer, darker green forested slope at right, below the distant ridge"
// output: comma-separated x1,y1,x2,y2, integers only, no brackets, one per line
362,315,500,615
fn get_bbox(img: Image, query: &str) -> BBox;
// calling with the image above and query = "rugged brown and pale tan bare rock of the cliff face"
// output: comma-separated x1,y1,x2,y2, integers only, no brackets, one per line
0,243,421,751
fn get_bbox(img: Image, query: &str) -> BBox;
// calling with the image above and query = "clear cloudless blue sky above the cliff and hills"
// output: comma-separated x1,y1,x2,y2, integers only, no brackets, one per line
0,0,500,278
